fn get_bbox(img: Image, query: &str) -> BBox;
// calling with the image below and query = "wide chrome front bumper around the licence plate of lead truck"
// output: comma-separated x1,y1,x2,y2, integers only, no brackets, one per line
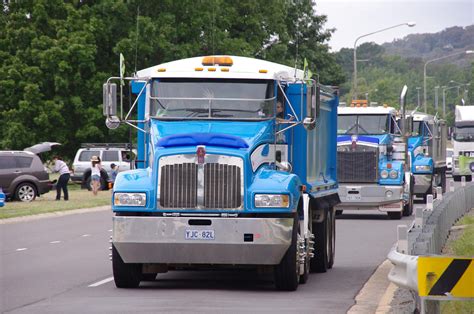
112,216,293,265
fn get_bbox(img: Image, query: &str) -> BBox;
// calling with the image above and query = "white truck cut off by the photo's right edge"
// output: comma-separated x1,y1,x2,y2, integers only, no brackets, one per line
453,106,474,181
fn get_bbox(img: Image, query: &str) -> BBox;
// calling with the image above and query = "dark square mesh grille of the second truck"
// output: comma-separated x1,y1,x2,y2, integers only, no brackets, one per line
337,151,378,183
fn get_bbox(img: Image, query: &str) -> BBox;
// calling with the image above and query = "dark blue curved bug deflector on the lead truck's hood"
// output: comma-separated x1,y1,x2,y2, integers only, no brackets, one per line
156,133,249,148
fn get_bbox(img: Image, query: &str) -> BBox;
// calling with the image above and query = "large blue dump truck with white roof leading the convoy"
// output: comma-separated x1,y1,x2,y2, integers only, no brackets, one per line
104,56,339,290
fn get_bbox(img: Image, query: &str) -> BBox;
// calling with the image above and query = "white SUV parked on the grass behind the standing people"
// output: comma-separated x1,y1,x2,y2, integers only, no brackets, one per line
71,143,136,188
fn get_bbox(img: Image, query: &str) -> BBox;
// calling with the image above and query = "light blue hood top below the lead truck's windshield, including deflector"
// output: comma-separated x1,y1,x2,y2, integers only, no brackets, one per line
151,120,274,150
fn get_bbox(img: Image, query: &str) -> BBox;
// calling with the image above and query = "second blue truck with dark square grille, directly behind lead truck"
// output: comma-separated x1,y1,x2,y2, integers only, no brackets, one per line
337,106,410,217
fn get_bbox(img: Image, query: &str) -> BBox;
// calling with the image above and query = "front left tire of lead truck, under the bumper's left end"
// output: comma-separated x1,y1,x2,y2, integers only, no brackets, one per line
112,245,142,288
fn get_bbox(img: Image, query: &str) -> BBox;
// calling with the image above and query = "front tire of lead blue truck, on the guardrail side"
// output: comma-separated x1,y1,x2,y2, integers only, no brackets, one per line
274,217,300,291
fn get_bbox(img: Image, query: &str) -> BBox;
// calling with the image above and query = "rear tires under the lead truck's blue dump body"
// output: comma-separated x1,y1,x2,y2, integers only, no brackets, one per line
310,209,335,273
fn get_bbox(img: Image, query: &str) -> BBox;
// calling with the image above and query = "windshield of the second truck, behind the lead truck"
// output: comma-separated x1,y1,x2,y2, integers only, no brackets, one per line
337,114,389,135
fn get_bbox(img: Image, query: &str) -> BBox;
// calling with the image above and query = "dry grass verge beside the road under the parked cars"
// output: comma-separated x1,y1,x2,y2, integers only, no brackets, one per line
0,185,112,219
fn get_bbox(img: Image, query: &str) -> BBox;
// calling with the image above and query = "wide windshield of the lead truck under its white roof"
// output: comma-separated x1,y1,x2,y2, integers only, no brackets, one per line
150,79,275,120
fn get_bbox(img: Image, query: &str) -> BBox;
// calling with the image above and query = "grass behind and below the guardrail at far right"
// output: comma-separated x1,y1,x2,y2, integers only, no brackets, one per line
441,209,474,314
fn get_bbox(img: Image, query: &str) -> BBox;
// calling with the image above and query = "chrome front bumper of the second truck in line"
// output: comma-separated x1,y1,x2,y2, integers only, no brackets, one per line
337,184,403,211
